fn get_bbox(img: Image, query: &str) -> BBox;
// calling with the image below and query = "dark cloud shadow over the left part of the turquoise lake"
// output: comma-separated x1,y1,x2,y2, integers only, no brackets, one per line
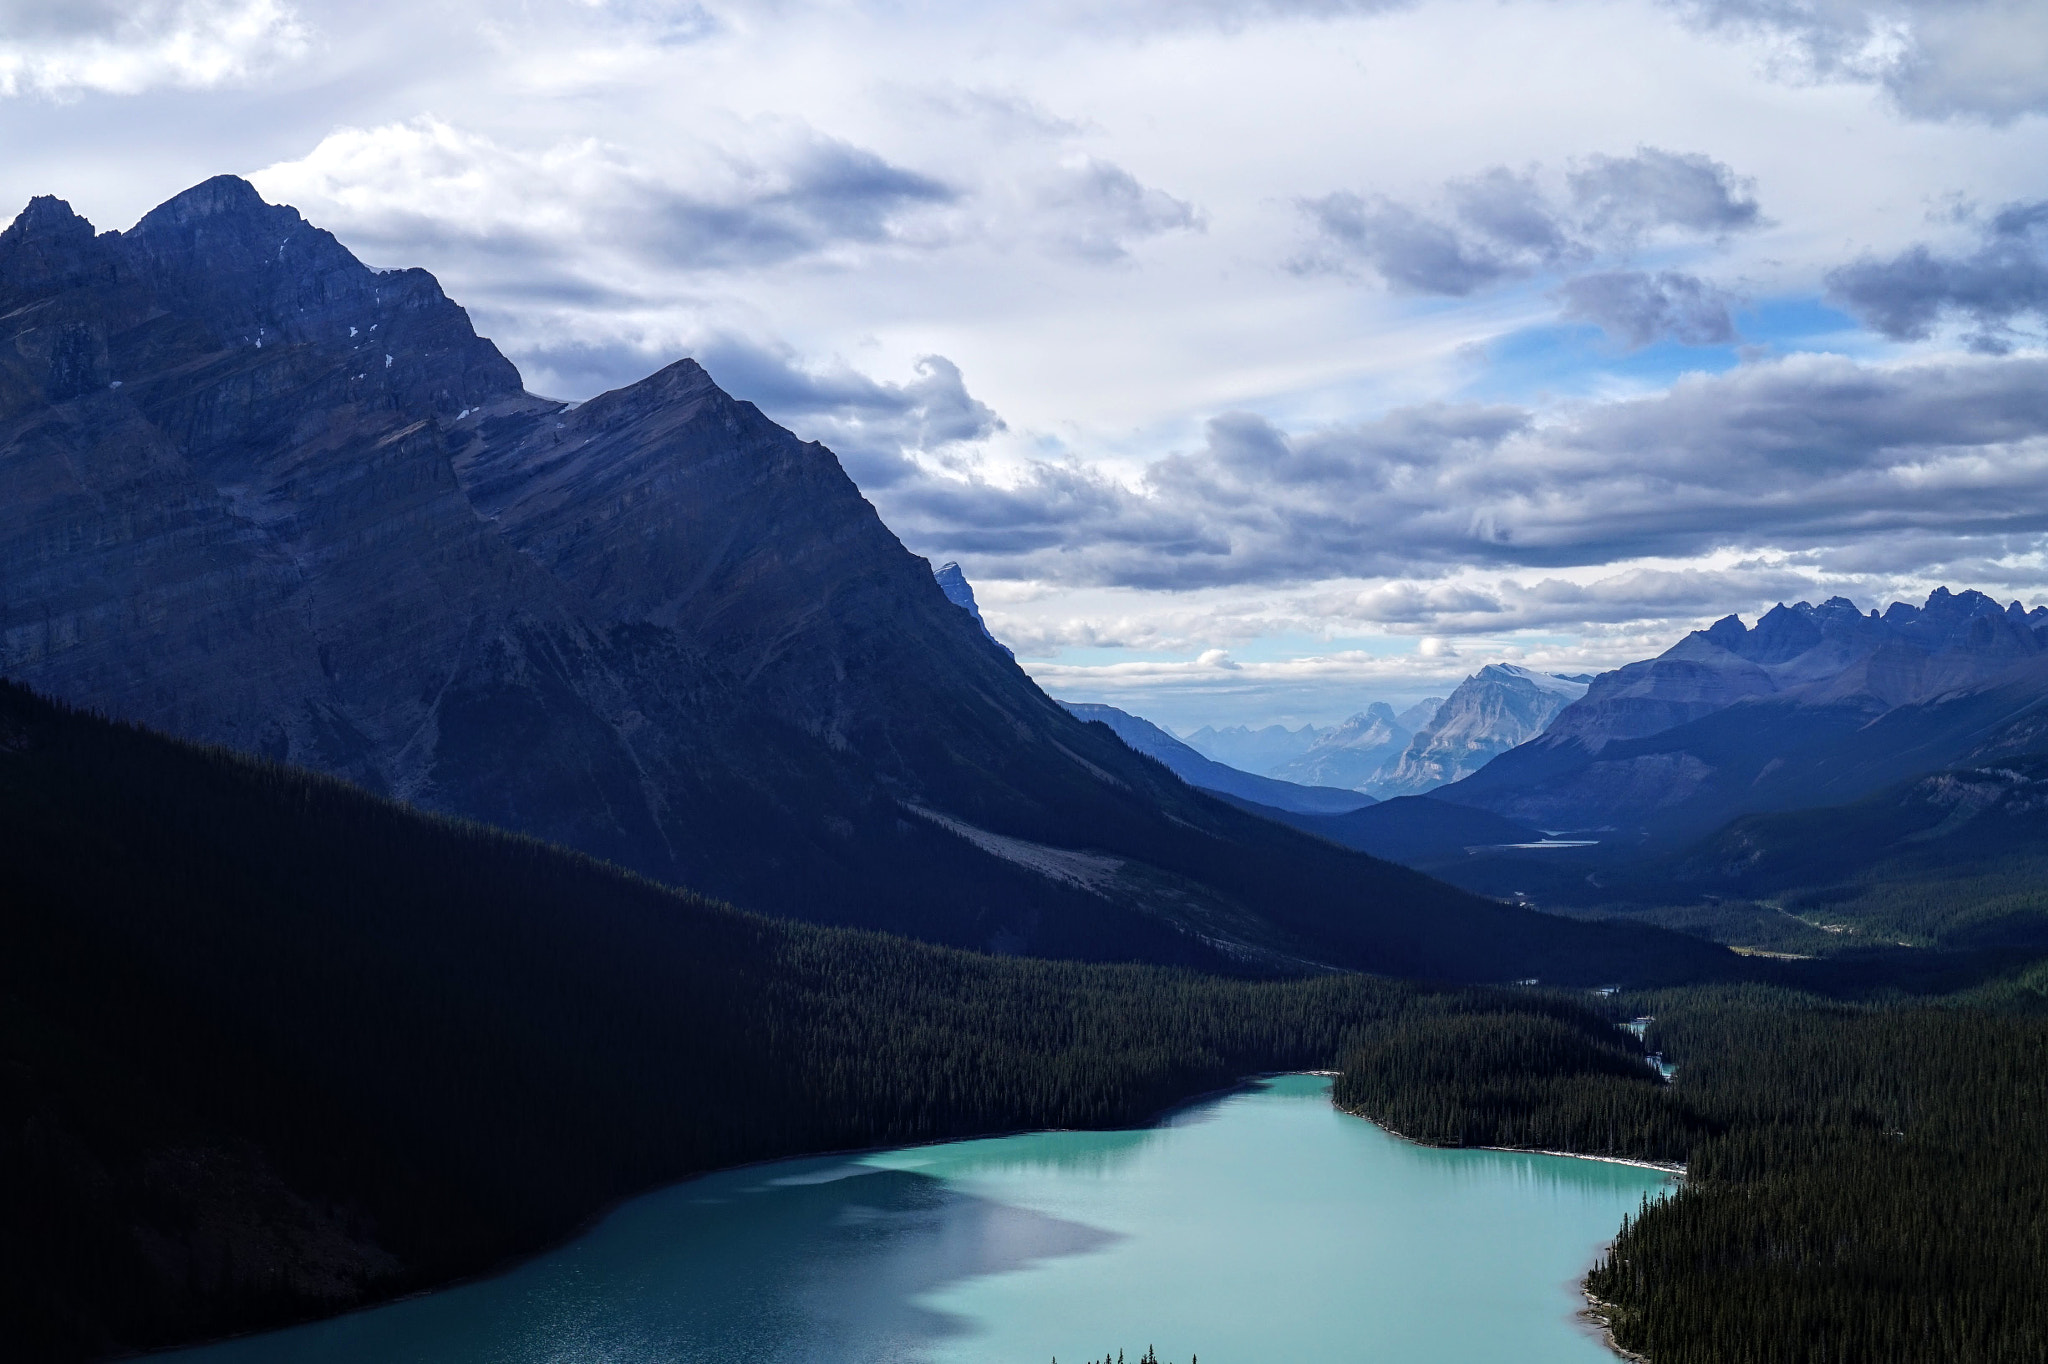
168,1159,1120,1364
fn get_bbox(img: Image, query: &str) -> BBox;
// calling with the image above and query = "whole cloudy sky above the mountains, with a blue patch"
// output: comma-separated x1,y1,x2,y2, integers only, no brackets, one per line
0,0,2048,729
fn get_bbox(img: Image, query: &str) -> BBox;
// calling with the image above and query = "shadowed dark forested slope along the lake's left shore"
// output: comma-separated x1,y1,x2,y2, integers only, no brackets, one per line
0,684,1430,1360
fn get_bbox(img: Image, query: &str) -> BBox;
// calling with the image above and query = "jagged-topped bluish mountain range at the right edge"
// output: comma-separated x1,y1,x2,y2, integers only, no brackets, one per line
1438,588,2048,844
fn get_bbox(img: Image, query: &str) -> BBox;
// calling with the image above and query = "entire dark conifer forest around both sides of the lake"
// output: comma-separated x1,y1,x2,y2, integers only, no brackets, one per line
0,671,2048,1364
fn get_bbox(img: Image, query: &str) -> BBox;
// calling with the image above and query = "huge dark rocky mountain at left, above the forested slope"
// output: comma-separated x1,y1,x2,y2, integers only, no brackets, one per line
0,176,1712,979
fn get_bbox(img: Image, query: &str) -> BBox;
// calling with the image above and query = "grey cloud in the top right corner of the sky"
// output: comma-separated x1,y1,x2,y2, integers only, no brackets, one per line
1667,0,2048,123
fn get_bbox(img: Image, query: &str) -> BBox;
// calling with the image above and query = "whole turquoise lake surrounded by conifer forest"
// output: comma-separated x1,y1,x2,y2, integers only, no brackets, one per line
158,1075,1669,1364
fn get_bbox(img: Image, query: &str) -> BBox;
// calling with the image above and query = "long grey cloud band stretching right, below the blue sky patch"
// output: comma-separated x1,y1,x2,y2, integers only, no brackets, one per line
877,356,2048,588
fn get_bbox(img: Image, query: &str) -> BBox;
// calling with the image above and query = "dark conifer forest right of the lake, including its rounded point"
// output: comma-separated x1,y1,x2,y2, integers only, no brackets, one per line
1337,971,2048,1364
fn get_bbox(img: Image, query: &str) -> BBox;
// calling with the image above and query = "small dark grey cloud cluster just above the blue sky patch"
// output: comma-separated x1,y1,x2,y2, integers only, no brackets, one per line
1292,147,1763,346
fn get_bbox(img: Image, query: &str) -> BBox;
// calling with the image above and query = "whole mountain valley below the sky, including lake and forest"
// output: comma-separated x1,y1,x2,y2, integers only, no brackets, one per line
0,176,2048,1364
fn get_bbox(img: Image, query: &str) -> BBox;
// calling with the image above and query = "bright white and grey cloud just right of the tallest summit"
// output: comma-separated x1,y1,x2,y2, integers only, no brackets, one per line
256,119,961,321
